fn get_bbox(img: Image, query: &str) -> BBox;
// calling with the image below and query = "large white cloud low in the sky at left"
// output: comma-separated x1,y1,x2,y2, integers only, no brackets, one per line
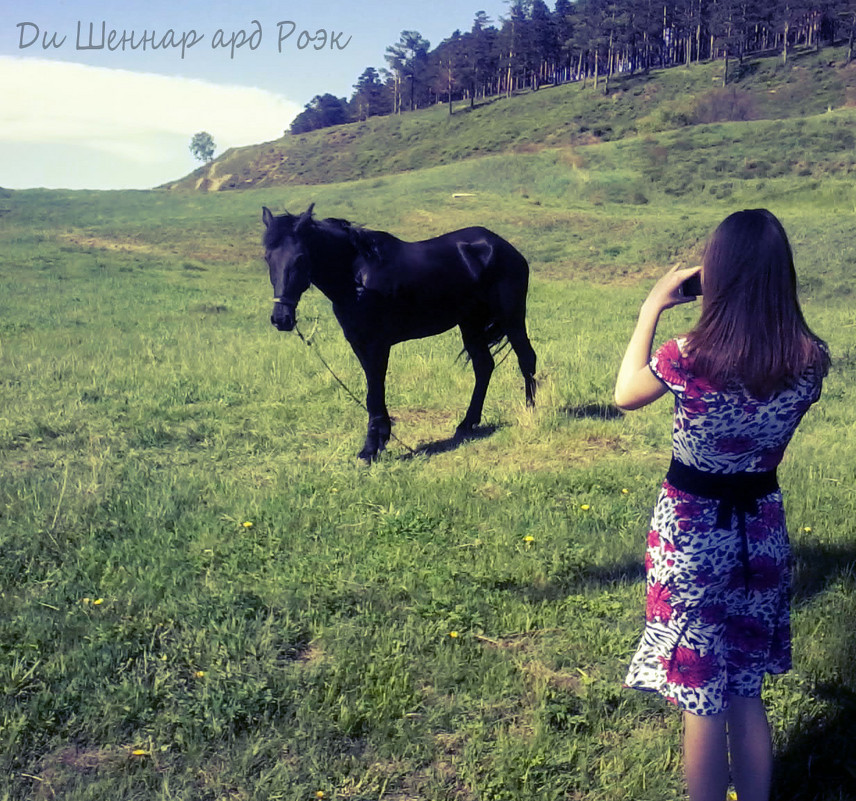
0,56,302,188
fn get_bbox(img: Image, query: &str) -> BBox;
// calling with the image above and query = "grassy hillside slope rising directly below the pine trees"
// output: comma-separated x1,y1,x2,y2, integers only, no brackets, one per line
165,49,856,191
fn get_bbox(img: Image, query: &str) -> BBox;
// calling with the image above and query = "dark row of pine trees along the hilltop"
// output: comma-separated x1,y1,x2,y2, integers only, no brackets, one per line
291,0,856,133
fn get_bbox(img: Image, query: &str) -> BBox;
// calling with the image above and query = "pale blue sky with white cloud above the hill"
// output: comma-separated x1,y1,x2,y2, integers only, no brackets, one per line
0,0,508,190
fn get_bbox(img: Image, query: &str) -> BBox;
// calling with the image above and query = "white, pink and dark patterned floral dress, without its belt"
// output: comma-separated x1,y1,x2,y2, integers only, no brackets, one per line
625,340,822,715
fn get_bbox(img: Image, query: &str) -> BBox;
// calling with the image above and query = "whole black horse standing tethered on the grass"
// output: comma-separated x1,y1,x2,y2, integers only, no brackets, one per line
262,204,535,461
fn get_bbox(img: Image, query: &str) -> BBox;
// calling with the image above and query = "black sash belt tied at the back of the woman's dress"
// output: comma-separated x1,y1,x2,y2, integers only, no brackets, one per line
666,457,779,593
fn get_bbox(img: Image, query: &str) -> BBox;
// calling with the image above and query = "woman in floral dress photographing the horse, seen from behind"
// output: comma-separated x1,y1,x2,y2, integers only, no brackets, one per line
615,209,829,801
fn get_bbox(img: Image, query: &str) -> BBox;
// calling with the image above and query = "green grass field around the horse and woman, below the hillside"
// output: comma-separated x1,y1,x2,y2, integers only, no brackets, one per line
0,69,856,801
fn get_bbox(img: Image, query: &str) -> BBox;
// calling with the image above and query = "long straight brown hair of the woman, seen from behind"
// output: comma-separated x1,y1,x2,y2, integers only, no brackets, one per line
688,209,829,397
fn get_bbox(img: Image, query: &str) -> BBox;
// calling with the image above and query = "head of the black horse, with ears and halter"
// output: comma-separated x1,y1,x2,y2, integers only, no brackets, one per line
262,203,315,331
